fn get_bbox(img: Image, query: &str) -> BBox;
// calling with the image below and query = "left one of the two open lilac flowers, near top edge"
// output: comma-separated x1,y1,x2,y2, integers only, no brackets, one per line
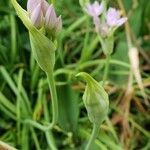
84,1,103,17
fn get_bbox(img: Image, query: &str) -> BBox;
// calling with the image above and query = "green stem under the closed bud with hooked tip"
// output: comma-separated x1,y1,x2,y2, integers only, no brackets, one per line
85,124,99,150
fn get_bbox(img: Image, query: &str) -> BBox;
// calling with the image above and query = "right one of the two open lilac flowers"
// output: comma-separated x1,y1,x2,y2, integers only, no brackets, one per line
106,7,127,27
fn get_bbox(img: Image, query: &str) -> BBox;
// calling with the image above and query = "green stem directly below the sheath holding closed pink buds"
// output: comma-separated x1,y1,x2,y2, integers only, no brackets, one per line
46,71,58,126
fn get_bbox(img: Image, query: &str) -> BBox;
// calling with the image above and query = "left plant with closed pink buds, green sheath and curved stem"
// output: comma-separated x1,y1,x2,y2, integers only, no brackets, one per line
11,0,62,128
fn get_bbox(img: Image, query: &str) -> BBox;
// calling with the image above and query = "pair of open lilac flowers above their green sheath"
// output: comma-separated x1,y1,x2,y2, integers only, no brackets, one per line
84,1,127,37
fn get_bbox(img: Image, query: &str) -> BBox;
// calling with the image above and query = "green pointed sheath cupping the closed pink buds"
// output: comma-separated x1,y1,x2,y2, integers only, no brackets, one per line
11,0,56,72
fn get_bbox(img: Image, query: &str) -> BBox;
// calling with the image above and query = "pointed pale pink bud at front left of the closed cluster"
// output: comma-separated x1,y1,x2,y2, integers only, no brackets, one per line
31,3,43,28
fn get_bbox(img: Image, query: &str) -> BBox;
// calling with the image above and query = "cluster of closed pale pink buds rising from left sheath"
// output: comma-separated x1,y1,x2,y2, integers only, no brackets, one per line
27,0,62,35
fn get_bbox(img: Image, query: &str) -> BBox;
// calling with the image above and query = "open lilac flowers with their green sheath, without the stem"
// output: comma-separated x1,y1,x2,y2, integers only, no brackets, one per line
83,1,127,55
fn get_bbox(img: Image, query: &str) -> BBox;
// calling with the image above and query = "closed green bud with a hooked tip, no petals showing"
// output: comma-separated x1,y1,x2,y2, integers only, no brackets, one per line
77,72,109,124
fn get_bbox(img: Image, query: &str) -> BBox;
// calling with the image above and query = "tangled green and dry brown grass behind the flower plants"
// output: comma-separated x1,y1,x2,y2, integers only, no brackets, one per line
0,0,150,150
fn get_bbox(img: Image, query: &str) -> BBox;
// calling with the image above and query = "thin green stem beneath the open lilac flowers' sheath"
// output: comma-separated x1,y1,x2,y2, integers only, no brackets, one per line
103,55,111,85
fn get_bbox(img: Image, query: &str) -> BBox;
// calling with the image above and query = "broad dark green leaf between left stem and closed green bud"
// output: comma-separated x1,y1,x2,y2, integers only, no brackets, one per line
57,85,79,133
